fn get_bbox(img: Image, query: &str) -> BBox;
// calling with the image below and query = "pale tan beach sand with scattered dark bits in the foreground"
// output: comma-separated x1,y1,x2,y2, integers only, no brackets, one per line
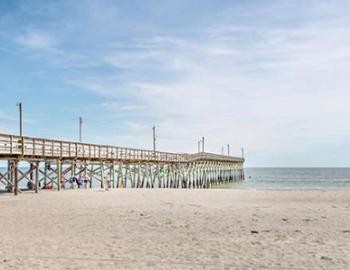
0,189,350,270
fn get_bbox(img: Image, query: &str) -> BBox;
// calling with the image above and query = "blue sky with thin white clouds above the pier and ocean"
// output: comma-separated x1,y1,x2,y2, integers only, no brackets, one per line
0,0,350,167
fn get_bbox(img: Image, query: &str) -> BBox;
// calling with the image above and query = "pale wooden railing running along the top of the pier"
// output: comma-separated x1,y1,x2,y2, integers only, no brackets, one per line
0,133,243,162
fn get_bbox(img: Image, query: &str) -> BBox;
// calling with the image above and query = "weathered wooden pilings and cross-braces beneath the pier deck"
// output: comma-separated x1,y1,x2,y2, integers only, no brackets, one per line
0,154,244,195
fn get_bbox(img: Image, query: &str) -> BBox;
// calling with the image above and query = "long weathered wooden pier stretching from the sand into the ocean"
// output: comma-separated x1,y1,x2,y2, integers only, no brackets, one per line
0,134,244,195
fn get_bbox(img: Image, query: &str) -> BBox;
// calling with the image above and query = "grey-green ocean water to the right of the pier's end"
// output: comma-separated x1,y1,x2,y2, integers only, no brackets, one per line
222,168,350,191
